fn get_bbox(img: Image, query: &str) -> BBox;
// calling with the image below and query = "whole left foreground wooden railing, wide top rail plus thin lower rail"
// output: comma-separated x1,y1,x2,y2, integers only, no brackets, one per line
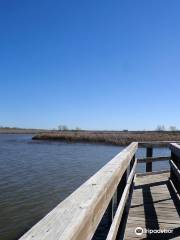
20,142,138,240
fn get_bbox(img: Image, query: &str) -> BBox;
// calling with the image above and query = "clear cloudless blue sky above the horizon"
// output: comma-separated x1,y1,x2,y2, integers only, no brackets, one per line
0,0,180,130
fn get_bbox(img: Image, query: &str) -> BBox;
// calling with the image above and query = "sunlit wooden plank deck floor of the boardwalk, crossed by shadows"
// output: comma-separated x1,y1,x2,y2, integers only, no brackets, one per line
124,173,180,240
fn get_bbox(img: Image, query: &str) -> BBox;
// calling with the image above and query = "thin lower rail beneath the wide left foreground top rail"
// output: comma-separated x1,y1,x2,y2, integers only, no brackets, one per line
106,159,137,240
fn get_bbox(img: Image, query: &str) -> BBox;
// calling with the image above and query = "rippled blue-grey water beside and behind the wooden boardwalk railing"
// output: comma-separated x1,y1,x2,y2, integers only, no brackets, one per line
0,134,169,240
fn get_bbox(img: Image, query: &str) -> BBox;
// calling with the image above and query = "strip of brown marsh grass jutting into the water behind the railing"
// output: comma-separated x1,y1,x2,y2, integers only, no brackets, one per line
33,131,180,146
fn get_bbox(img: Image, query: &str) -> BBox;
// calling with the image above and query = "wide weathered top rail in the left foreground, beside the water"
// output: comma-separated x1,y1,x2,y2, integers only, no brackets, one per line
20,142,138,240
